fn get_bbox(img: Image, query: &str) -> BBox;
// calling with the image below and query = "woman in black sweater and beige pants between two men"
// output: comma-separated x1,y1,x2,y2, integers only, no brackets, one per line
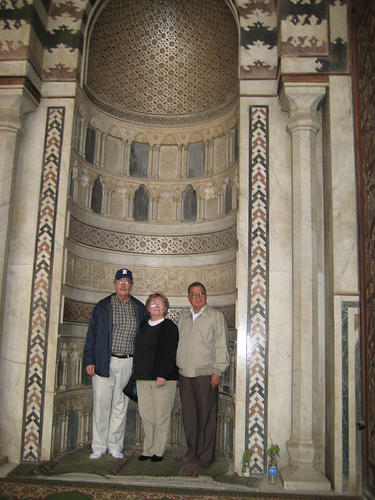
134,293,178,462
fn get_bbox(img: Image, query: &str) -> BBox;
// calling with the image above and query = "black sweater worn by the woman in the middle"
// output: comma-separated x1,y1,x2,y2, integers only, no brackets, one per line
133,319,178,380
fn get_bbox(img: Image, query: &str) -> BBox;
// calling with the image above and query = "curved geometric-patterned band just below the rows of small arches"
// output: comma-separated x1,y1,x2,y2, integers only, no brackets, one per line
69,217,237,255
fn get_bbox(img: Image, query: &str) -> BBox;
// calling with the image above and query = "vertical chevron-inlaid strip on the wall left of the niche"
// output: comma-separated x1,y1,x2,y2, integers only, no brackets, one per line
22,108,65,461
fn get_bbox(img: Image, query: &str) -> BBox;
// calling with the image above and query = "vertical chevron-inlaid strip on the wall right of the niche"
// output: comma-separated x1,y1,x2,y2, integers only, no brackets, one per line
247,106,269,475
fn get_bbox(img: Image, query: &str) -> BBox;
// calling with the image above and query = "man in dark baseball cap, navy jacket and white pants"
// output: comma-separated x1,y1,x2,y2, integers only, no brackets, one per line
83,269,147,459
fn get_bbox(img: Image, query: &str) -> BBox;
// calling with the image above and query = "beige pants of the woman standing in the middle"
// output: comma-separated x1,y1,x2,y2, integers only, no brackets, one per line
137,380,177,457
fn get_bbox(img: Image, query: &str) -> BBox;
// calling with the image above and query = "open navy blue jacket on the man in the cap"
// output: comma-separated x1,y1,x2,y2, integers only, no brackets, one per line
83,293,147,377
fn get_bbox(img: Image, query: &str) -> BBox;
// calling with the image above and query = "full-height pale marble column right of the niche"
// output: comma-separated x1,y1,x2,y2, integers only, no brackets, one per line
281,84,331,491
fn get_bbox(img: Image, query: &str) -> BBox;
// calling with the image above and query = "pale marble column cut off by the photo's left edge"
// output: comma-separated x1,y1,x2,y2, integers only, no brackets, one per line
0,87,37,332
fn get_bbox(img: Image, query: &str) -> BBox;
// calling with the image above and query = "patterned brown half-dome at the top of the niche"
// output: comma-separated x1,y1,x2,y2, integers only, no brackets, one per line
85,0,238,123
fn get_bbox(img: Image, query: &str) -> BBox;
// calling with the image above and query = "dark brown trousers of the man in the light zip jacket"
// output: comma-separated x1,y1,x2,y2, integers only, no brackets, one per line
179,375,219,463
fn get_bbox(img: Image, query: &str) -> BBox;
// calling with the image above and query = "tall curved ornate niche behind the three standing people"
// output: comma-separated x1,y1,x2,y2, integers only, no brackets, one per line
59,0,239,468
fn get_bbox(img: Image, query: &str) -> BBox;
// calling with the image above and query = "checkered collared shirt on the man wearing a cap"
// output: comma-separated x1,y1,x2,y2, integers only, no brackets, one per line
111,295,137,356
